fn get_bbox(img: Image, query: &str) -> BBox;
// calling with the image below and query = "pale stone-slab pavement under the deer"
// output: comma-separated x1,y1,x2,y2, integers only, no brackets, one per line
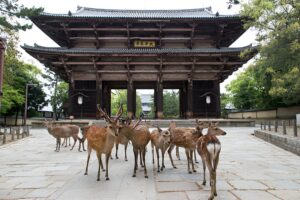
0,128,300,200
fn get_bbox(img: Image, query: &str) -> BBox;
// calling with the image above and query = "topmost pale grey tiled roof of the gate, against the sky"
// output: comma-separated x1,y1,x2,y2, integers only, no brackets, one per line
41,7,239,19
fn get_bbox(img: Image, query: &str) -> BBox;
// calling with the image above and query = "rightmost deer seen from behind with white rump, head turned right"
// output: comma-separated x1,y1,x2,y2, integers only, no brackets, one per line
197,123,226,200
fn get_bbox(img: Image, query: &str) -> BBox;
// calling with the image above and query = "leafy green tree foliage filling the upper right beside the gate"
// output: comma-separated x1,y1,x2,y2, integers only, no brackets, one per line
227,0,300,109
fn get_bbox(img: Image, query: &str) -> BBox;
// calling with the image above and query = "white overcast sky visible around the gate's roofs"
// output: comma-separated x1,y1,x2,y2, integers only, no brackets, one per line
19,0,255,92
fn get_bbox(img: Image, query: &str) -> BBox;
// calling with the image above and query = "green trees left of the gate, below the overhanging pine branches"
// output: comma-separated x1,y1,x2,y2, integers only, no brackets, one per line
1,31,46,123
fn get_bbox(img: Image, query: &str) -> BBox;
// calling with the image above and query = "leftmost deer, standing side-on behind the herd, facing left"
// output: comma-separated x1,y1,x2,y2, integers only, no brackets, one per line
44,121,80,152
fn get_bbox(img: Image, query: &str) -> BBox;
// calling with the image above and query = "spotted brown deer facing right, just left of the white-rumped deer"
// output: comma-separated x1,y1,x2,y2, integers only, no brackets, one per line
168,121,206,174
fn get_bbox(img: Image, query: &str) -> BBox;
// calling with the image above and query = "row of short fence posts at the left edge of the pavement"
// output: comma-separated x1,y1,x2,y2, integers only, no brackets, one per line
0,125,30,144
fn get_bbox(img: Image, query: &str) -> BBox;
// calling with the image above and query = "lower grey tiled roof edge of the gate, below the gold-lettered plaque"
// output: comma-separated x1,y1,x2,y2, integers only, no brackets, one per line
22,44,256,54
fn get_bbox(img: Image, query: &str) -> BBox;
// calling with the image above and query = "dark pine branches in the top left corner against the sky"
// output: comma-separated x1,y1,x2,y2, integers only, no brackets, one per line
0,0,43,32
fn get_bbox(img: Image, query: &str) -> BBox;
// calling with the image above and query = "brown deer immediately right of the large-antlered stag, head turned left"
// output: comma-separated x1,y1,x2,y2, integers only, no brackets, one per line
119,119,150,178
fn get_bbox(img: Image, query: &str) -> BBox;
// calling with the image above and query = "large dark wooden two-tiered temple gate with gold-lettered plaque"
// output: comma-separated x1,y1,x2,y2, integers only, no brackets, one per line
23,7,256,118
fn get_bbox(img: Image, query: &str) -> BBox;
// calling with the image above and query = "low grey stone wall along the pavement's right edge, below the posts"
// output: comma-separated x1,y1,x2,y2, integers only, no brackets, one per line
254,130,300,156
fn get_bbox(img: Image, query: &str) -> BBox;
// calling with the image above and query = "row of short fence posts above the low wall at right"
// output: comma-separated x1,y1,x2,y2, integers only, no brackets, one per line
260,120,299,137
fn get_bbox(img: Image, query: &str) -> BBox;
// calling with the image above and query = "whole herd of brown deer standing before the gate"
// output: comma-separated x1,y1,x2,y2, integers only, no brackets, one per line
45,105,226,199
